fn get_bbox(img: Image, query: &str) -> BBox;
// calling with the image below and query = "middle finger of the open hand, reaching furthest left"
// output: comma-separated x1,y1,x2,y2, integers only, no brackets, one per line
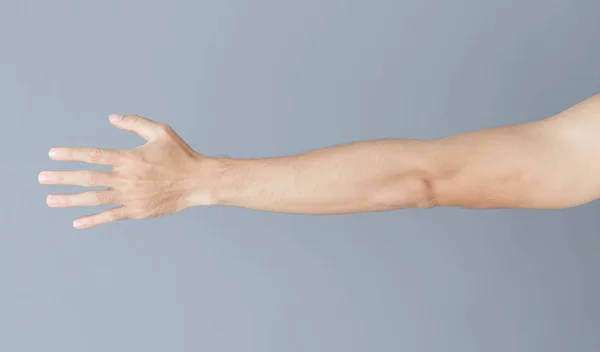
38,170,114,187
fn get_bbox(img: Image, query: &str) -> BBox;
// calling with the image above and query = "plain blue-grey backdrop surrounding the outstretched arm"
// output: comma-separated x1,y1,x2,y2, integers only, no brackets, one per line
0,0,600,352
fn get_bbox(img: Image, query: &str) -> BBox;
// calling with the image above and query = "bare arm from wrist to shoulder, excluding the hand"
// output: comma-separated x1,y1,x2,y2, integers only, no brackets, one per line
205,95,600,214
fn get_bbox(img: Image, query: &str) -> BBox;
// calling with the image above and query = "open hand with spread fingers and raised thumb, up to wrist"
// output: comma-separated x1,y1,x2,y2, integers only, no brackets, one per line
39,115,210,229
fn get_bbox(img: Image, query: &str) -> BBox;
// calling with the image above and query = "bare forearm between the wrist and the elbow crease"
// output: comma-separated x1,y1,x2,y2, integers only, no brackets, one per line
199,140,434,214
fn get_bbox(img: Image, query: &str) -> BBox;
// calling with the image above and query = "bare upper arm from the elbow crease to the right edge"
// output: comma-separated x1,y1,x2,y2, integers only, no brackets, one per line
435,95,600,209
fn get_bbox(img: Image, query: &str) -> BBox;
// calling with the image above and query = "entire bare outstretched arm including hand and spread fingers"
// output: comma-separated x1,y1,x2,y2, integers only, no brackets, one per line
39,95,600,229
